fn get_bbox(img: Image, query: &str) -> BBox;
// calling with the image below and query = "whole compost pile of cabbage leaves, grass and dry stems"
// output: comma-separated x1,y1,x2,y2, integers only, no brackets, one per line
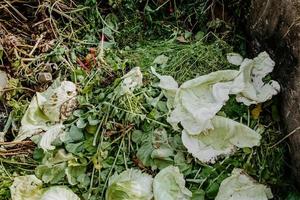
0,0,297,200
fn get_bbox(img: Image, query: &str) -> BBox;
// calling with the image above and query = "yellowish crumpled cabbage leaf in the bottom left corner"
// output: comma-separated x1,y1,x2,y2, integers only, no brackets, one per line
10,175,43,200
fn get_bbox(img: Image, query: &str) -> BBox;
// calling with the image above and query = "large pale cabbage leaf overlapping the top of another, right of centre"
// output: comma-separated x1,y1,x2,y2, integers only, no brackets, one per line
168,70,240,135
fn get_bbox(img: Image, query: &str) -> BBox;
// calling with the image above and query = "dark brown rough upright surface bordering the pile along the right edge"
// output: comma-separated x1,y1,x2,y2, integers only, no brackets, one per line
247,0,300,189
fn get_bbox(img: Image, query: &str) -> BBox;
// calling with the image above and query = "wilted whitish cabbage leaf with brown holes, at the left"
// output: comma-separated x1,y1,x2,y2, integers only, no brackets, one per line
15,80,77,150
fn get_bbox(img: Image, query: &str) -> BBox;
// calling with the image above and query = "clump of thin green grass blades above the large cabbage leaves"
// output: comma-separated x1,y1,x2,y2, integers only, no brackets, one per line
122,37,233,83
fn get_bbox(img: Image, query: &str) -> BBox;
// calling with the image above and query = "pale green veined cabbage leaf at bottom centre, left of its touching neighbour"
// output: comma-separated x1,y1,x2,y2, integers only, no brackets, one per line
105,169,153,200
